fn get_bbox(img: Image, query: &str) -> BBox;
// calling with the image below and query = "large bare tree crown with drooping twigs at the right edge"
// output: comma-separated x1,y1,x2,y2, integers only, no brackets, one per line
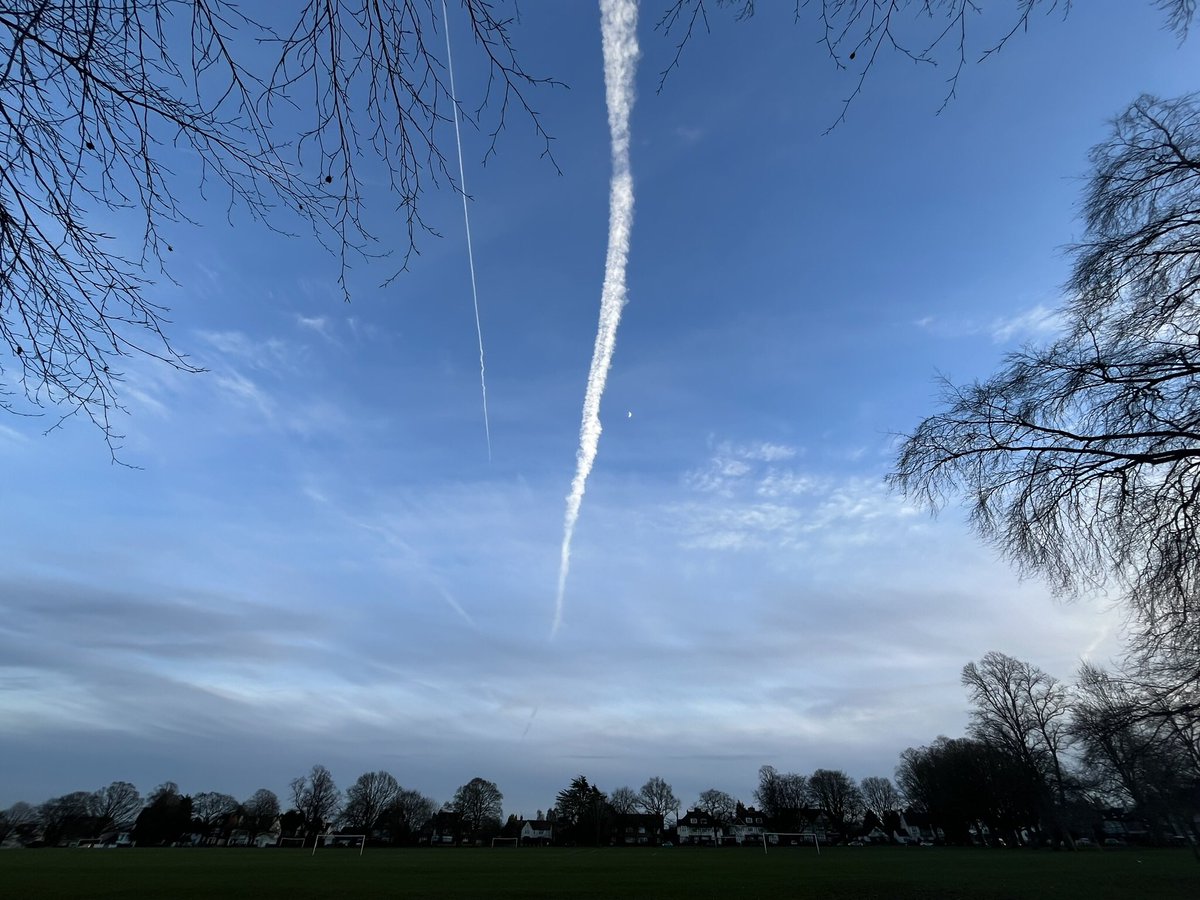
890,95,1200,684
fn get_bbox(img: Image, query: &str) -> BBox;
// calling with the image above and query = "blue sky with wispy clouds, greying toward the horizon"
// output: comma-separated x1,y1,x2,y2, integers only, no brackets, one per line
0,0,1198,816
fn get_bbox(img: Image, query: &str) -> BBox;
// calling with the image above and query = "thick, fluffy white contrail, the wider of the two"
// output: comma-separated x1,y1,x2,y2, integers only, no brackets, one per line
550,0,637,637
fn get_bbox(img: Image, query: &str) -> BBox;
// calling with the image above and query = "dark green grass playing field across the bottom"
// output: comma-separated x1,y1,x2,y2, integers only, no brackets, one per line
0,847,1200,900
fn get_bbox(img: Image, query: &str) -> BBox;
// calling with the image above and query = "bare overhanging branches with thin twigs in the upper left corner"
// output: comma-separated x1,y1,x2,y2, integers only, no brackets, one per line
0,0,559,450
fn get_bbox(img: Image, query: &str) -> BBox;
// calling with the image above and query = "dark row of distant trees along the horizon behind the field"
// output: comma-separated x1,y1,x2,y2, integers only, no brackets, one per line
0,652,1200,850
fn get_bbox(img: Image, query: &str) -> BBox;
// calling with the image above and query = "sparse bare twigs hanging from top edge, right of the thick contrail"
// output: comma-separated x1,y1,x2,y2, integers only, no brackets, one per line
656,0,1196,125
